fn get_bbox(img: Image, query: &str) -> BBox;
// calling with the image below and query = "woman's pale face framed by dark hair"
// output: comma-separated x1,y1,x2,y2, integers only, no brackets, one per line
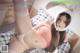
56,15,66,29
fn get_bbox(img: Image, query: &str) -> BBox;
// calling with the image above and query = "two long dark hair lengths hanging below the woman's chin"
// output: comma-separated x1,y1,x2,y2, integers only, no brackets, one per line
45,24,66,52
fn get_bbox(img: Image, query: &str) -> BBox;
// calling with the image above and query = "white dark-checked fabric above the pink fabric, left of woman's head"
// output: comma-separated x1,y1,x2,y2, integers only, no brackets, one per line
32,9,48,26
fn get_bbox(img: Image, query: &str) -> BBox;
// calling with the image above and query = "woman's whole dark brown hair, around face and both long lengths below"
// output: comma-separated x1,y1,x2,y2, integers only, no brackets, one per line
47,12,71,52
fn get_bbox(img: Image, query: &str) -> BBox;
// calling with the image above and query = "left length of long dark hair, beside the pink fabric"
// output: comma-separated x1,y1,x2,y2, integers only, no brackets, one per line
46,24,58,52
